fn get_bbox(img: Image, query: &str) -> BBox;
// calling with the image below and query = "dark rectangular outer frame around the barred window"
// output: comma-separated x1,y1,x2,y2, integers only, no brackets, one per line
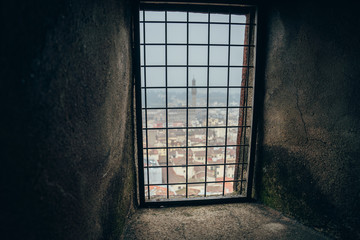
133,1,258,207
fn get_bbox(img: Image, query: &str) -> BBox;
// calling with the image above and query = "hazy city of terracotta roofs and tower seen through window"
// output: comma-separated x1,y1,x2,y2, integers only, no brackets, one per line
143,79,249,199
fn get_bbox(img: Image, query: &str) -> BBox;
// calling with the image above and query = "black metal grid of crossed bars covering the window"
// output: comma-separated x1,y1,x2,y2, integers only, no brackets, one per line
139,4,256,202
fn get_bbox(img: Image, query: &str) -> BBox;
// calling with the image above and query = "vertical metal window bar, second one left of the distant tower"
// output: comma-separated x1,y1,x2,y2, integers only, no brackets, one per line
165,11,169,198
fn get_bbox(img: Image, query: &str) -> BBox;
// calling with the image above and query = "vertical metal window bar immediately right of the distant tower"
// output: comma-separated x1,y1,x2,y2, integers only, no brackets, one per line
204,12,210,197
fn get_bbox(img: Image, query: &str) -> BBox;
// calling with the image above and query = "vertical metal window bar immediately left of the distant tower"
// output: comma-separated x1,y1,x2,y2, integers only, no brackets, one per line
186,11,189,198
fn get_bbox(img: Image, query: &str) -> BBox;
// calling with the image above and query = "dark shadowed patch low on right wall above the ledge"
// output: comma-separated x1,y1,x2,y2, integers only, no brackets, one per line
256,146,360,239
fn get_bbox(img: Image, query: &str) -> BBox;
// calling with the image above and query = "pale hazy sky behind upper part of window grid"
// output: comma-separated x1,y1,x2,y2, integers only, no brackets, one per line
140,11,246,87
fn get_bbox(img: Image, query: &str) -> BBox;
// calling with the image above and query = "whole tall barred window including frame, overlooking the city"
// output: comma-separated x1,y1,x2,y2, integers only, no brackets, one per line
137,1,256,205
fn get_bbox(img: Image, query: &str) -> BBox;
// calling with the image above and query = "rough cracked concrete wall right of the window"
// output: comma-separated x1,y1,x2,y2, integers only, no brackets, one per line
258,1,360,239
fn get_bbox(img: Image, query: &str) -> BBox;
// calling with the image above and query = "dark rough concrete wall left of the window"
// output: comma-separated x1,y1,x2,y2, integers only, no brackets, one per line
0,0,135,239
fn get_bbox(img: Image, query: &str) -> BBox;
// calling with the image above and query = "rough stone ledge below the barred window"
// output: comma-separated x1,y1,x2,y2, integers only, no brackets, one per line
122,203,330,240
